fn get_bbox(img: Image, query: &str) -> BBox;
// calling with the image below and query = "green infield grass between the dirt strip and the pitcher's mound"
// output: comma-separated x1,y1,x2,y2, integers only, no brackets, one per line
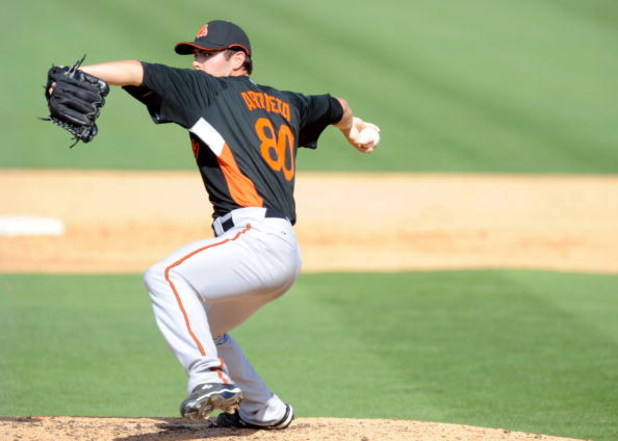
0,271,618,441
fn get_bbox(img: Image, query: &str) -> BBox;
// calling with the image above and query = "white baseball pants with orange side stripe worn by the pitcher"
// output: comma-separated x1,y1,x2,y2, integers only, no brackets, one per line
144,208,301,424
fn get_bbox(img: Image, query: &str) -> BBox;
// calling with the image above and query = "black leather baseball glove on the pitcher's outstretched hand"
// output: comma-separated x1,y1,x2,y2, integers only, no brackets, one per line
45,56,109,147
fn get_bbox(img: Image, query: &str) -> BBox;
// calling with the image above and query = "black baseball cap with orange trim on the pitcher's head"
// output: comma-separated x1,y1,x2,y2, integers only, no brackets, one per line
174,20,251,55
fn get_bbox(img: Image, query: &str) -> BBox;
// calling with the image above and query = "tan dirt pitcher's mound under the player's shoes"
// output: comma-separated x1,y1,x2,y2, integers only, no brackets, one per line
0,417,588,441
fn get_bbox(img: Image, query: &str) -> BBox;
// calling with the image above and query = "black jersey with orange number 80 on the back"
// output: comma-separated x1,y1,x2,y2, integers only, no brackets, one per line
125,63,343,223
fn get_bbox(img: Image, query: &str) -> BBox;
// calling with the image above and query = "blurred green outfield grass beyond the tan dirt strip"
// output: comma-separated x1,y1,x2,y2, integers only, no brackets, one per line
0,0,618,173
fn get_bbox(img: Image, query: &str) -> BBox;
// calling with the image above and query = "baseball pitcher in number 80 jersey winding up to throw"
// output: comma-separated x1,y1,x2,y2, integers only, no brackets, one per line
46,20,379,429
